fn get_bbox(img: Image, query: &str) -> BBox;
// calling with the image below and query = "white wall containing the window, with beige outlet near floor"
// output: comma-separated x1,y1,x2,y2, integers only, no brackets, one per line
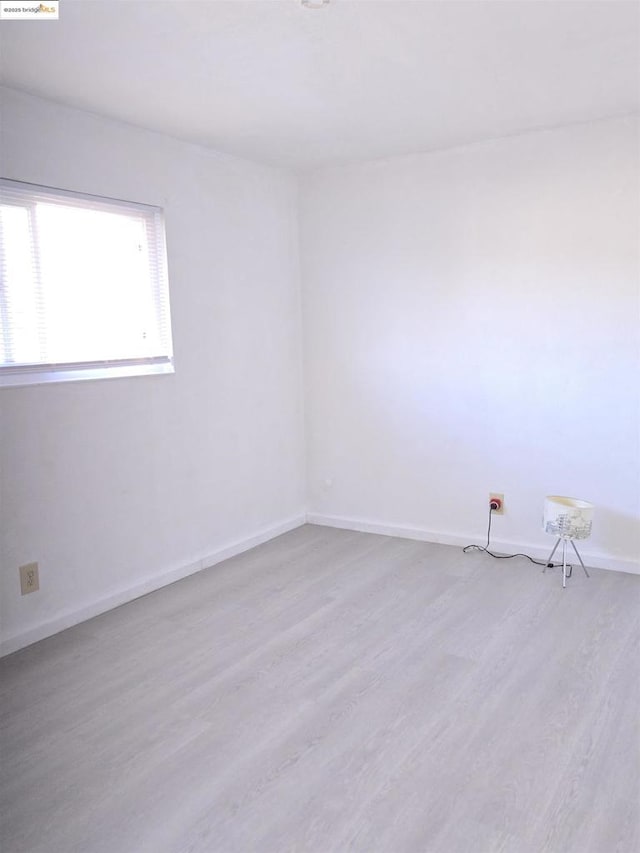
0,90,304,651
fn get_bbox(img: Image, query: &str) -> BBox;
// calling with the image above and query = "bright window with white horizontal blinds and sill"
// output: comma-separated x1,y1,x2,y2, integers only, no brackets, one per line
0,179,173,386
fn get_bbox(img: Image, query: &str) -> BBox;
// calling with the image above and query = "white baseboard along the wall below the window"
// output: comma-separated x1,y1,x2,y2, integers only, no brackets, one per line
0,515,306,657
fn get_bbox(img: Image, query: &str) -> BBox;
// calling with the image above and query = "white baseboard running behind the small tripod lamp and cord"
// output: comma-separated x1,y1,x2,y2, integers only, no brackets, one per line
307,512,640,575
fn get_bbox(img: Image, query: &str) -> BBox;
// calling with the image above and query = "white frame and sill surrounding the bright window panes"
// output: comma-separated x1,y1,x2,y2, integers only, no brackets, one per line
0,177,175,389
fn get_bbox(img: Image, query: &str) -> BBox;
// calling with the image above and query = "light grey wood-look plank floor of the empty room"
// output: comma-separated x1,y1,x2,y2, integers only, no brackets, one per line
0,526,640,853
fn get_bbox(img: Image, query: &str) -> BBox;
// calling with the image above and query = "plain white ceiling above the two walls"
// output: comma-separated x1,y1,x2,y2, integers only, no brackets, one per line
0,0,640,170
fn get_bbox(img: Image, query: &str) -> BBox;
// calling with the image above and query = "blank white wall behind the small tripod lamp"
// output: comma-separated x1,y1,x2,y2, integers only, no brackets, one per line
301,119,640,570
